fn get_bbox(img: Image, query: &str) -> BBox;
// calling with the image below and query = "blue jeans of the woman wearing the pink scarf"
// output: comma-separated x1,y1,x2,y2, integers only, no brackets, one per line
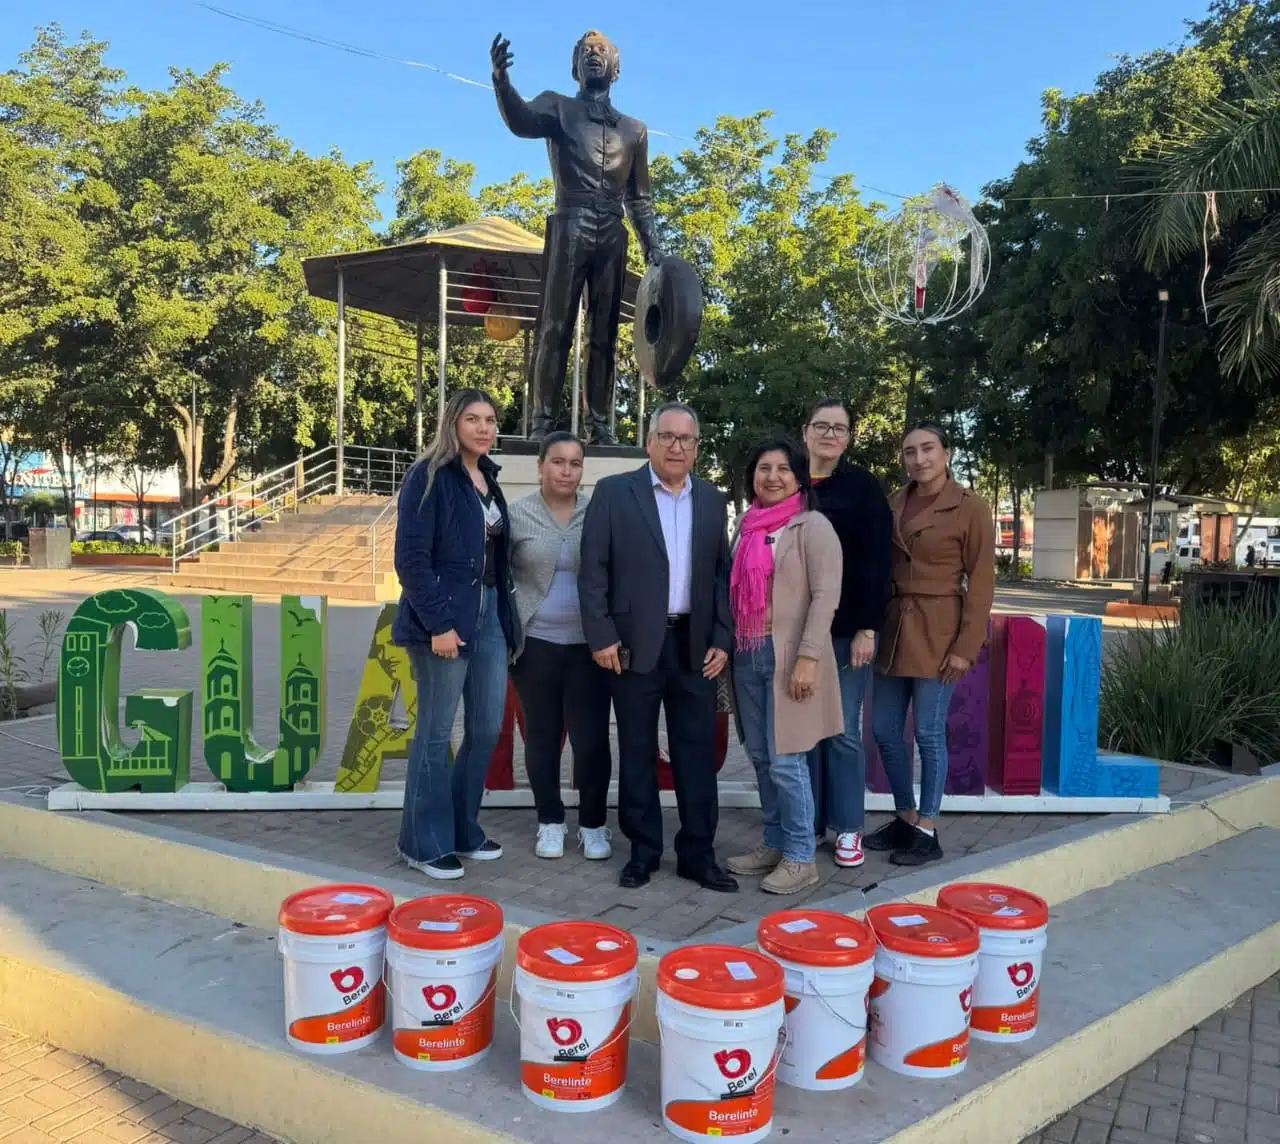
733,650,814,862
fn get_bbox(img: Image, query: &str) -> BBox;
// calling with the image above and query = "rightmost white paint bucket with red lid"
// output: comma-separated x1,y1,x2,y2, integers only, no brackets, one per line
938,882,1048,1044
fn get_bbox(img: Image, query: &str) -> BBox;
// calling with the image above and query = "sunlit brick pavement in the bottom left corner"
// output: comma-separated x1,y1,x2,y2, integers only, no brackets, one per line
0,1028,280,1144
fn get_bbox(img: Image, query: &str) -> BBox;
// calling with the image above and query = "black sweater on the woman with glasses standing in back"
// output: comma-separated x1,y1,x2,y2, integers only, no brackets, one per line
814,461,893,639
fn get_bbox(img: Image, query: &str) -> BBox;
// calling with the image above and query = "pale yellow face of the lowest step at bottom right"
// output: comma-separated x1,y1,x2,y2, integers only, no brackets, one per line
883,924,1280,1144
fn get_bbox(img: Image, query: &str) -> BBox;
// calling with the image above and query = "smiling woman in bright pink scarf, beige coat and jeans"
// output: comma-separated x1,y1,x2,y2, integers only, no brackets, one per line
728,438,845,893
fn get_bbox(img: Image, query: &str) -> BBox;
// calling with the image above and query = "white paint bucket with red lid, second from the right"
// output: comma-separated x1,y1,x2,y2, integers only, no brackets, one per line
867,902,979,1077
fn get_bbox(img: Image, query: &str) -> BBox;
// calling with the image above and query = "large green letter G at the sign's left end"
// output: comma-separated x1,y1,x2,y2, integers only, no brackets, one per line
58,587,191,792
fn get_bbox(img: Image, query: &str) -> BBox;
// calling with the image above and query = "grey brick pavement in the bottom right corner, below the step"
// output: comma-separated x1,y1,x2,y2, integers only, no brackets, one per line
1023,975,1280,1144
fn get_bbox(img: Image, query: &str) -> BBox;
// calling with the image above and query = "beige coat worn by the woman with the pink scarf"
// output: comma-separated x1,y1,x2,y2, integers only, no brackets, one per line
735,512,845,755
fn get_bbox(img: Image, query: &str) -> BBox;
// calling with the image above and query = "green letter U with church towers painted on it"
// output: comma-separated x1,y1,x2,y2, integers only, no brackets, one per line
201,596,328,791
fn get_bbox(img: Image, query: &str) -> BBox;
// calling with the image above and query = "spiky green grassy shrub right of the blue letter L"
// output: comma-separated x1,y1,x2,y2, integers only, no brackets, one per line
1101,601,1280,763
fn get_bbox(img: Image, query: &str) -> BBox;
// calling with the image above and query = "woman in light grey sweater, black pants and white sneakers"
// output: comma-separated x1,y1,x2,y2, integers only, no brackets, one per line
511,433,613,860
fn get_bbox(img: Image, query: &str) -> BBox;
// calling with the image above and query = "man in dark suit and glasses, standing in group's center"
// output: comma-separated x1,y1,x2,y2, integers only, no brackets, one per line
577,403,737,893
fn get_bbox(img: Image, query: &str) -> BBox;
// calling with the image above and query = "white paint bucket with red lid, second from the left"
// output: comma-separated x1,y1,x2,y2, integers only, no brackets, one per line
387,894,503,1072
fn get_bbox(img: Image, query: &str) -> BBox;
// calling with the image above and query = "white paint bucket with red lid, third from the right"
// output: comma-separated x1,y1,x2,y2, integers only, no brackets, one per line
756,910,876,1092
